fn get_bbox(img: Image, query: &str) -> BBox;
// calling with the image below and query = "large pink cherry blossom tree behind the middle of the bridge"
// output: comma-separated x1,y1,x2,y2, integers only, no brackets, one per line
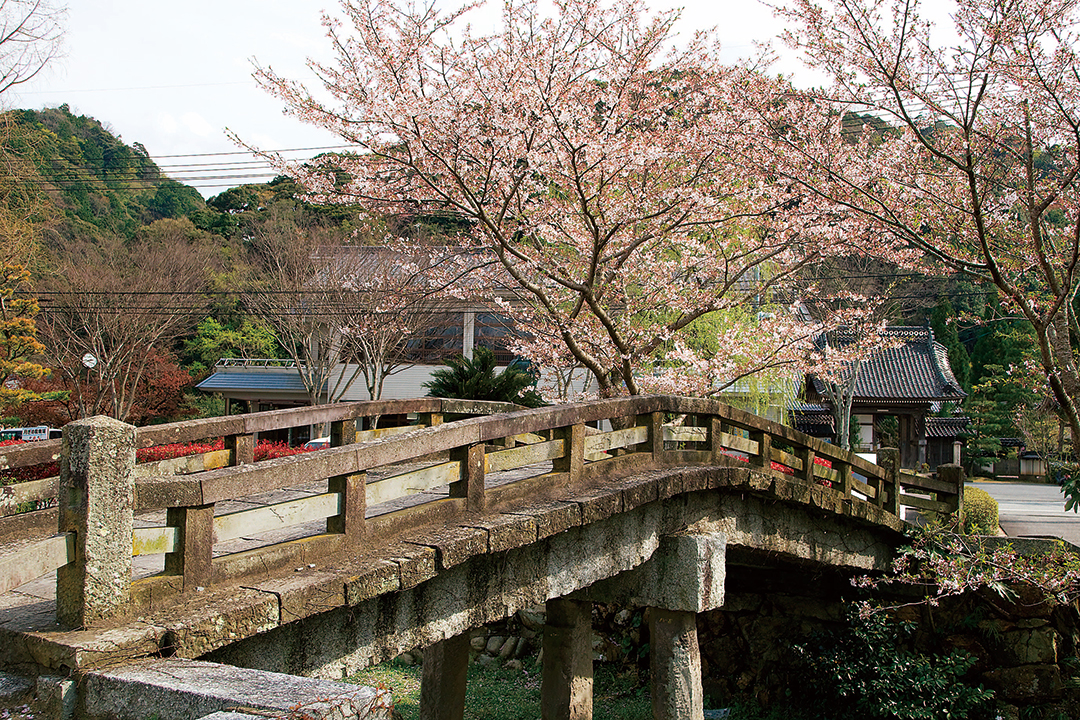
248,0,838,396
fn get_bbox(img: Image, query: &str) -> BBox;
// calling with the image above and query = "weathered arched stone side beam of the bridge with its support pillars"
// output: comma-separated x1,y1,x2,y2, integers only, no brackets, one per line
205,467,899,718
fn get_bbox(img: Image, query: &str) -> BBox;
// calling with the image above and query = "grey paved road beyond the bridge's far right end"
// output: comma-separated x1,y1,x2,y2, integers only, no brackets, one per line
972,483,1080,545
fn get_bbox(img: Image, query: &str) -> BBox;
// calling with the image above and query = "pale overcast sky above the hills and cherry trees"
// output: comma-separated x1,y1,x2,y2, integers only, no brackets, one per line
4,0,799,196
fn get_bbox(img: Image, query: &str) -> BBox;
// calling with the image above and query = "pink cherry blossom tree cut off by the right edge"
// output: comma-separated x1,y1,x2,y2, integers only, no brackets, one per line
743,0,1080,507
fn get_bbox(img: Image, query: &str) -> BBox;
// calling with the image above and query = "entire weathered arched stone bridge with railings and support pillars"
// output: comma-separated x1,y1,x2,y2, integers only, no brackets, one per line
0,396,959,717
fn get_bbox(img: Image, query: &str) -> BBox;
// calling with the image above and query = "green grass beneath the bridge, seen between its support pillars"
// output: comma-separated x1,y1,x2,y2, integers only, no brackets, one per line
349,660,652,720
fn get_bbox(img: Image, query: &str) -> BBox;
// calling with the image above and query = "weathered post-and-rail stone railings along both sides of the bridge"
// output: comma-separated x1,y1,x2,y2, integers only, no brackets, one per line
0,396,962,627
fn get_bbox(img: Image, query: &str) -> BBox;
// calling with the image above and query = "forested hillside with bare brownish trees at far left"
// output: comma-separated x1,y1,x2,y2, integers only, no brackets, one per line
0,105,370,425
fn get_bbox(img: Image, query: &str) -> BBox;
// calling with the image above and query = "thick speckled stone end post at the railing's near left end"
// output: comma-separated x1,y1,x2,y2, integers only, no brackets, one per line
56,416,135,627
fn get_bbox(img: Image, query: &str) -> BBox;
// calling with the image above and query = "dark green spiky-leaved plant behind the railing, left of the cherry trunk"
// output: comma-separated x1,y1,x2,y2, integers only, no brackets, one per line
423,348,545,407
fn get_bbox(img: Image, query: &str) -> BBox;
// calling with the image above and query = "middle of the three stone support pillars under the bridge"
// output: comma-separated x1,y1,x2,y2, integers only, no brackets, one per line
540,598,593,720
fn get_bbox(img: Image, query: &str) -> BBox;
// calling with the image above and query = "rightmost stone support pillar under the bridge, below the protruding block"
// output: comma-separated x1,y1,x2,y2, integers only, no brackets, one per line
649,608,704,720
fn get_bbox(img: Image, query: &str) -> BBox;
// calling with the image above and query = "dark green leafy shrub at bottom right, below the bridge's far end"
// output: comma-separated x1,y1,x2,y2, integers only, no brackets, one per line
795,613,994,720
